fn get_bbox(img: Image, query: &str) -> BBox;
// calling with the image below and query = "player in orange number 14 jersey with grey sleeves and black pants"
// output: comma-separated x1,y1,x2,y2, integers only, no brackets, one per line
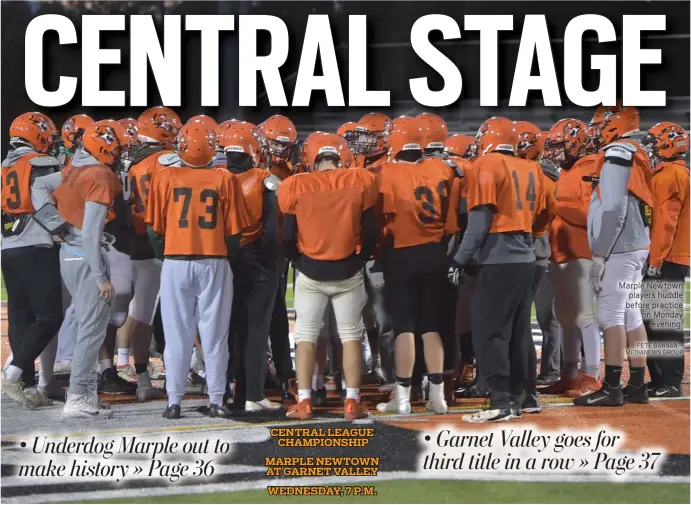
449,121,553,423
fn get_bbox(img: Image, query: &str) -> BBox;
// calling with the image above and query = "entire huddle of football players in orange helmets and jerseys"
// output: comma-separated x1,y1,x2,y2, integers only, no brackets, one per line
2,106,689,423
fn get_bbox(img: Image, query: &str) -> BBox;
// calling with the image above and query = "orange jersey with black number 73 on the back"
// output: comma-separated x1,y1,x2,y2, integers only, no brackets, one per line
146,166,249,257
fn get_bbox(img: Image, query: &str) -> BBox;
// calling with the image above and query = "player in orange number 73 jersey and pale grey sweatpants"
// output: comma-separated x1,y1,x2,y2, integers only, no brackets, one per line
146,121,249,419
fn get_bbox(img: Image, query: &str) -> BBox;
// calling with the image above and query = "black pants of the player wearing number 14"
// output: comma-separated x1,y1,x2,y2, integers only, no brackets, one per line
472,262,536,409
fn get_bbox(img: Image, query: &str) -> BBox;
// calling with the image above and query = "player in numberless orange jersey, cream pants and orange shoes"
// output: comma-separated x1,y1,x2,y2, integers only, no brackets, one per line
278,133,377,421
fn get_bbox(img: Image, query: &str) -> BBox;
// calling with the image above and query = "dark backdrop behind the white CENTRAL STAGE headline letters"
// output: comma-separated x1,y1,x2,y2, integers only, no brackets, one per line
1,1,691,158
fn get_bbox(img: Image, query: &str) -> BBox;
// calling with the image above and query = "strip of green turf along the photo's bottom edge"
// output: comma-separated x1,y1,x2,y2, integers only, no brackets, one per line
85,480,689,503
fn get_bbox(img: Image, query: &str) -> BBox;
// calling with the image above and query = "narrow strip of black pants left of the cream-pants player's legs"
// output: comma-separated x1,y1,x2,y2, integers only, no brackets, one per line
269,261,295,382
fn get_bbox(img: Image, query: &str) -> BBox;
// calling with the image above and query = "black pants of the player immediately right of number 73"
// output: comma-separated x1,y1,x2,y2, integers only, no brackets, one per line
228,244,278,408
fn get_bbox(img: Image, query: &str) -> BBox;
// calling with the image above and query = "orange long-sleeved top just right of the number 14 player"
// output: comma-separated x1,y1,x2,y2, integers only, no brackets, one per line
549,154,597,263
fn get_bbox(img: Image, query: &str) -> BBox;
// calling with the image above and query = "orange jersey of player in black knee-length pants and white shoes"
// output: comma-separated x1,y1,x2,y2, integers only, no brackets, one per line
379,158,460,248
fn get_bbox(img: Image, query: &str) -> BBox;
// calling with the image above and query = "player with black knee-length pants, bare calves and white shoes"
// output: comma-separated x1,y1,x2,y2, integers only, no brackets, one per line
377,117,458,414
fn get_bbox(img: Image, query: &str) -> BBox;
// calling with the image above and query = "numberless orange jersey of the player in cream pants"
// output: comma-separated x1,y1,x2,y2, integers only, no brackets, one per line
278,169,378,260
